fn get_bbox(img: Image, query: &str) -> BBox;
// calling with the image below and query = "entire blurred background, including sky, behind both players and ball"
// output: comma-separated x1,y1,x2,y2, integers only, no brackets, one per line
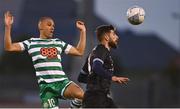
0,0,180,108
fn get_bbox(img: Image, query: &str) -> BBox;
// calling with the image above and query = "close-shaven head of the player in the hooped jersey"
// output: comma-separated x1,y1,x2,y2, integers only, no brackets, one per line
39,19,54,38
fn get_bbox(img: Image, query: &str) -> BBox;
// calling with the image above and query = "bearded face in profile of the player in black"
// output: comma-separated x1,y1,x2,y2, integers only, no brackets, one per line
108,30,119,48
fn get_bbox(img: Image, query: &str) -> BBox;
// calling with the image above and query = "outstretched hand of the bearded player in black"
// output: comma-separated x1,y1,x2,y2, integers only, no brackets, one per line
112,76,129,84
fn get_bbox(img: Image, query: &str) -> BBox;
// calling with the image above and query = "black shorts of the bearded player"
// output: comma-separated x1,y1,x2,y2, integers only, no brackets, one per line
83,91,117,108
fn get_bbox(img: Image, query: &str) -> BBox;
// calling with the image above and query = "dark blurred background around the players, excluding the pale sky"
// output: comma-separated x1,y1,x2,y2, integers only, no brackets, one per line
0,0,180,108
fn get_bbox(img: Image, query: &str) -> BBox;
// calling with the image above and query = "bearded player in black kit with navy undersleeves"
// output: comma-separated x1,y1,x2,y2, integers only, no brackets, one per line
78,25,129,108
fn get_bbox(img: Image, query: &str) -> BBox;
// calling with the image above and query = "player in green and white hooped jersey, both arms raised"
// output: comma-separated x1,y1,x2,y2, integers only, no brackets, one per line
4,11,86,108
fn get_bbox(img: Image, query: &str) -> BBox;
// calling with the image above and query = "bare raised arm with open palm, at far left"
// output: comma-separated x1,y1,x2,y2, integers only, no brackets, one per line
4,11,22,51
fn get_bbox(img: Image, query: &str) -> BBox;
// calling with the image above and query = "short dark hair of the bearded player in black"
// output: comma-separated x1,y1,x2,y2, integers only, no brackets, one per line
96,25,116,41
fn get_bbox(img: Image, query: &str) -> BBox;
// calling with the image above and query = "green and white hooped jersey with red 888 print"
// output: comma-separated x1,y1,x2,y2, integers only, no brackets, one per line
19,38,72,83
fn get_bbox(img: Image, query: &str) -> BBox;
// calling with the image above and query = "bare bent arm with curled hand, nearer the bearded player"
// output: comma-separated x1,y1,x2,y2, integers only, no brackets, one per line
68,21,86,56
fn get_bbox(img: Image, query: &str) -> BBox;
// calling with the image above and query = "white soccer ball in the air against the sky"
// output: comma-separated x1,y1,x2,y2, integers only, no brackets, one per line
127,6,145,25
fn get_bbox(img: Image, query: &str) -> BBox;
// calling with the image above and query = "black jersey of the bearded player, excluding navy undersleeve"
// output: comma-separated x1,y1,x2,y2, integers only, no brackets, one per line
82,44,114,92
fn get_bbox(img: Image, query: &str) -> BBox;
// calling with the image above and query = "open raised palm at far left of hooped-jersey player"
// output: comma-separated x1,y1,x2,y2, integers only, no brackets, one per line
4,11,14,26
